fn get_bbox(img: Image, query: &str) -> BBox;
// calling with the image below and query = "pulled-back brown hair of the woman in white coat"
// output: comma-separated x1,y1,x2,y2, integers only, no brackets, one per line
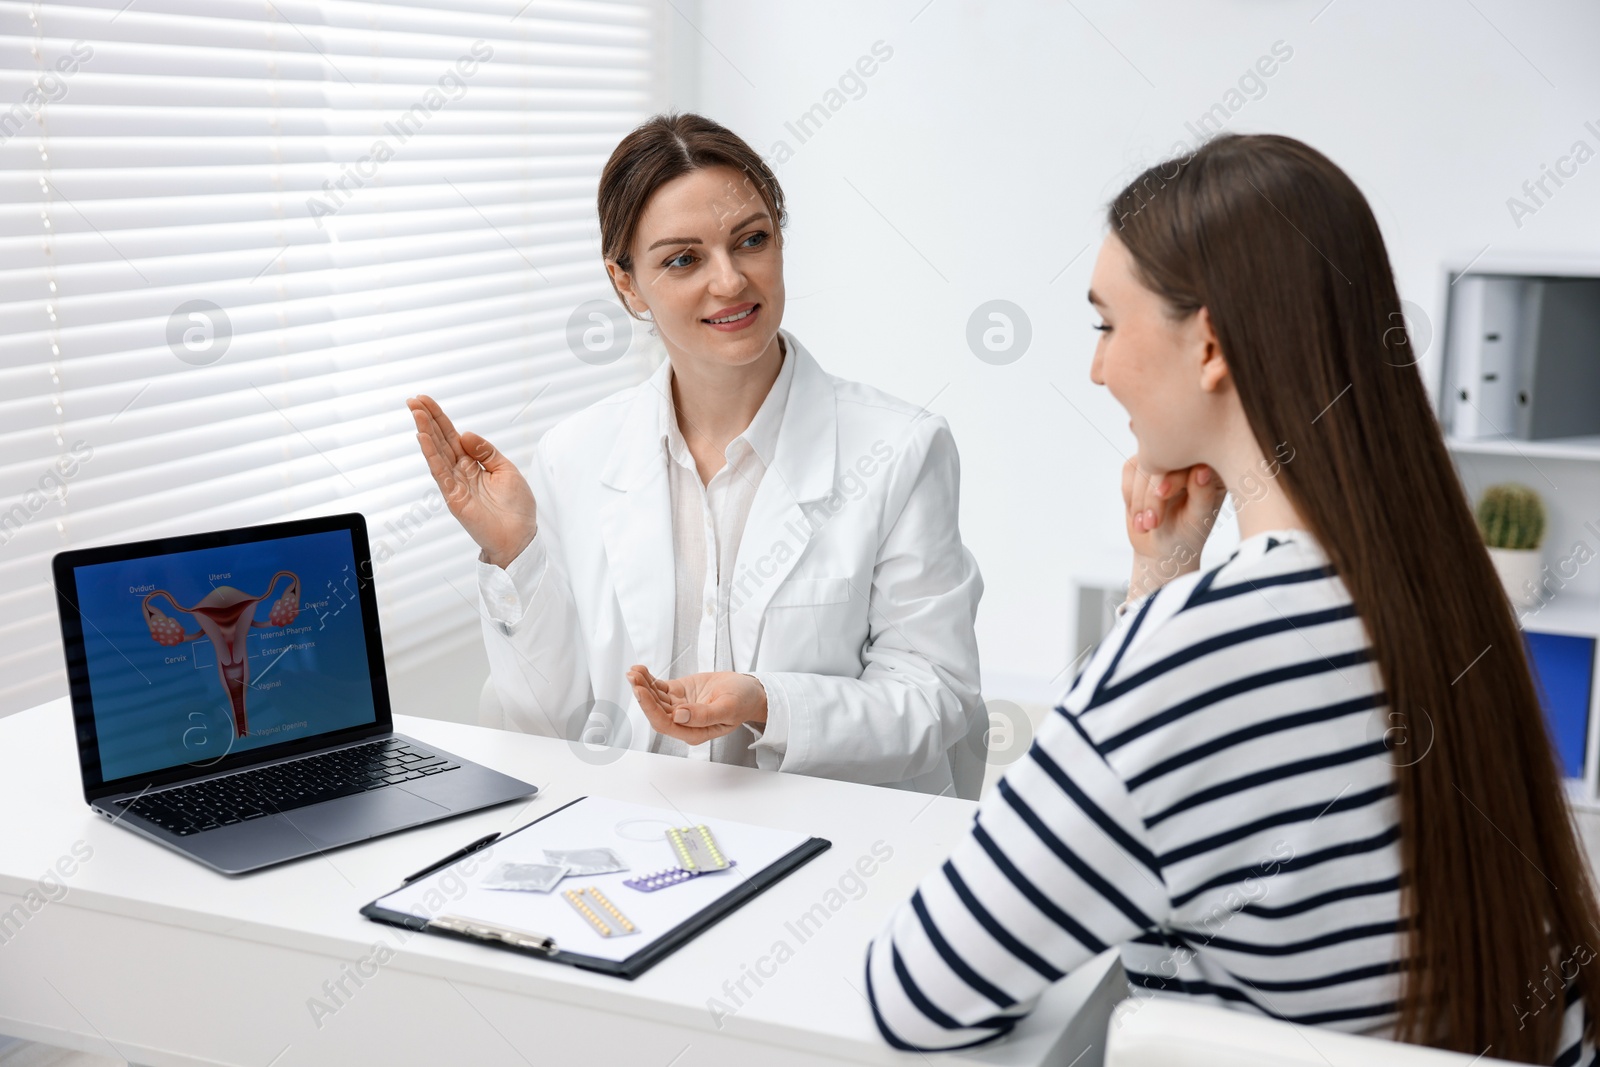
597,114,787,315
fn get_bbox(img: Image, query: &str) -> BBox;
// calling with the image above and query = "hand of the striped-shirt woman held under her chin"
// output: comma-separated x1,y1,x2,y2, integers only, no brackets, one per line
1122,456,1227,598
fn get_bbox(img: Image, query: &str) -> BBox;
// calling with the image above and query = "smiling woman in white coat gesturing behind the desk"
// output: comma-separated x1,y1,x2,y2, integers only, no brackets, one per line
408,115,987,797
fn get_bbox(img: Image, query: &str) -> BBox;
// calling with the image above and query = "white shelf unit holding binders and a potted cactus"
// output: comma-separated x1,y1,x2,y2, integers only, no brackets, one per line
1435,256,1600,809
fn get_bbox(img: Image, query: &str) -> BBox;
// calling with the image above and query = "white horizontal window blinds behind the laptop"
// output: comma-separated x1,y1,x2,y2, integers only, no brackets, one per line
0,0,659,713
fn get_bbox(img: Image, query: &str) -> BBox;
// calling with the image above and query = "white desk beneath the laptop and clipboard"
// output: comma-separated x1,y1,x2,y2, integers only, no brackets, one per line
0,699,1125,1067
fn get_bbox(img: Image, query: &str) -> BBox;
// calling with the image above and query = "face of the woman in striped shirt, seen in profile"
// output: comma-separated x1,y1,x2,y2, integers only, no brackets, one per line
1090,234,1237,470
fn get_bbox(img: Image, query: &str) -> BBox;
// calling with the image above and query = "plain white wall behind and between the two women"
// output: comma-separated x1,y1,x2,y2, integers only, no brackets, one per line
675,0,1600,699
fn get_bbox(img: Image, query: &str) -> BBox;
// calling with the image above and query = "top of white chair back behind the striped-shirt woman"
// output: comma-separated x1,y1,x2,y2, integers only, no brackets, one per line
1106,995,1510,1067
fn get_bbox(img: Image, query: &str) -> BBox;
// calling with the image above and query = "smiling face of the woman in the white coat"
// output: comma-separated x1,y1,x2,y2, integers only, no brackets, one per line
606,166,784,370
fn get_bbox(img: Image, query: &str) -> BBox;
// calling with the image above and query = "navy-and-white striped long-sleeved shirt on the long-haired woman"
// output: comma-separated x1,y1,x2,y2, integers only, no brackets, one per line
866,530,1594,1064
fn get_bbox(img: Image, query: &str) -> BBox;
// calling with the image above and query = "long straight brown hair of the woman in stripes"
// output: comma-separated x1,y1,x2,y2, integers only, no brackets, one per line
1107,134,1600,1064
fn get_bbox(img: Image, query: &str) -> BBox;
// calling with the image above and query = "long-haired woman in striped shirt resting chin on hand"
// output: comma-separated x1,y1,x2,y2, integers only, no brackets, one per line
867,136,1600,1064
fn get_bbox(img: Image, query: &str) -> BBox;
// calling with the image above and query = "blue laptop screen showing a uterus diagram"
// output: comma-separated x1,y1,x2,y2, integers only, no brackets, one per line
72,530,378,782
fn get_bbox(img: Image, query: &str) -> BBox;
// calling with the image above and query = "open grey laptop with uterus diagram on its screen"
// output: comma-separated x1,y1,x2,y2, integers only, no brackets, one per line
53,514,538,873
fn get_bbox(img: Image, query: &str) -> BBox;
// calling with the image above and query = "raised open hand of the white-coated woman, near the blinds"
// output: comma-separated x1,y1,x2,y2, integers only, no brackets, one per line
405,395,538,568
